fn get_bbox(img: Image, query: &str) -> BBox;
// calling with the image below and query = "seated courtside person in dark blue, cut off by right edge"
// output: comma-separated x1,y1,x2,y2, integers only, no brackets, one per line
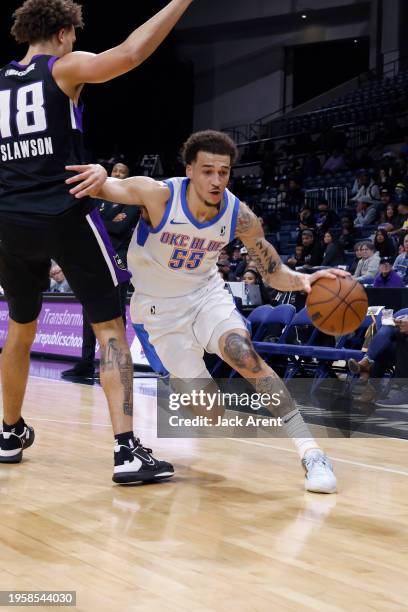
348,316,408,407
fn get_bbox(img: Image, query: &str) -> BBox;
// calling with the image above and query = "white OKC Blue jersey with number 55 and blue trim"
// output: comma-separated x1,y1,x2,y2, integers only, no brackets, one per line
128,178,239,298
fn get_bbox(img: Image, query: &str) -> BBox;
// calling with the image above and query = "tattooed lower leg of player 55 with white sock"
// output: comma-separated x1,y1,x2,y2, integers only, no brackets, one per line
220,329,319,458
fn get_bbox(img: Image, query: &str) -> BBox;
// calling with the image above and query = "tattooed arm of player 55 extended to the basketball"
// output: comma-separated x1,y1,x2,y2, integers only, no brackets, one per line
235,202,349,293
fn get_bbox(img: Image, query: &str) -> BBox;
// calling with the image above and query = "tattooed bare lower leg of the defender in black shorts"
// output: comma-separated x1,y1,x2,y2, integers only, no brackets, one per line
93,318,133,434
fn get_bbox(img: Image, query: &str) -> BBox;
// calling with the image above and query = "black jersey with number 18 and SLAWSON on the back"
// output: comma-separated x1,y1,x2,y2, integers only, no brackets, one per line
0,55,89,215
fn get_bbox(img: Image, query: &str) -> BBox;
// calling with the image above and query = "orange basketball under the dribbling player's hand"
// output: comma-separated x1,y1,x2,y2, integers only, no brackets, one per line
306,276,368,336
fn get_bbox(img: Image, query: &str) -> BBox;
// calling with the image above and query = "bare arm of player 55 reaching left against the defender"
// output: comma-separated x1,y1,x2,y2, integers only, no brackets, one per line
65,164,170,210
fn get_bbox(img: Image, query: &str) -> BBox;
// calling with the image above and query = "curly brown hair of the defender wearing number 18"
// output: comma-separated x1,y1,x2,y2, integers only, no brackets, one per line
11,0,84,44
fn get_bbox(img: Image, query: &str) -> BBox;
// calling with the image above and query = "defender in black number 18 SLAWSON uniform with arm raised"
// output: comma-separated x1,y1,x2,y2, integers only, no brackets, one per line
0,0,192,483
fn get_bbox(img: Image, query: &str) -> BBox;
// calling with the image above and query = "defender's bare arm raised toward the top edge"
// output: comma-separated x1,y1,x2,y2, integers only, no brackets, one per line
53,0,192,90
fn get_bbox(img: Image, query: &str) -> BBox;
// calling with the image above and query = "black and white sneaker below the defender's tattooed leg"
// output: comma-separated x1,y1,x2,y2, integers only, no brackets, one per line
112,438,174,485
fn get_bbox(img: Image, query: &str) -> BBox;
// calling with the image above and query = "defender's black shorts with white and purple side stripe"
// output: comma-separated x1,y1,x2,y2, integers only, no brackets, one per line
0,205,130,323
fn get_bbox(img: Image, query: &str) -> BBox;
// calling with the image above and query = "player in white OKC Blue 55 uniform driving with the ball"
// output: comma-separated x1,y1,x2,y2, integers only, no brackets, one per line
67,130,347,493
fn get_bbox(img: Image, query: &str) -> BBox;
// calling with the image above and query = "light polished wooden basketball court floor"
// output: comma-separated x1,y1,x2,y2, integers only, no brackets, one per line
0,378,408,612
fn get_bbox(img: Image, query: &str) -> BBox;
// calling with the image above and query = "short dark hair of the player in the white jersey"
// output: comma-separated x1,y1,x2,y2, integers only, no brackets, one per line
182,130,238,166
